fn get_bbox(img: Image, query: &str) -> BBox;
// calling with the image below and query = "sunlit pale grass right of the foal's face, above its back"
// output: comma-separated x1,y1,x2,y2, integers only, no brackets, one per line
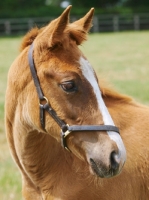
81,31,149,104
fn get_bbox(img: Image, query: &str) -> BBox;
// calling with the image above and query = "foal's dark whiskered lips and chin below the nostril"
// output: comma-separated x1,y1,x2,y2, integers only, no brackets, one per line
90,158,118,178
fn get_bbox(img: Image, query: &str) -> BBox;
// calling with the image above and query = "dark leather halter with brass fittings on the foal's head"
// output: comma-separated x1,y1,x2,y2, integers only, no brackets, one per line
28,44,119,151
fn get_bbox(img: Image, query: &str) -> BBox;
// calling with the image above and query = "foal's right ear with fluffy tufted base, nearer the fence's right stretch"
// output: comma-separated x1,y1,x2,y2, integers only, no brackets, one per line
69,8,94,45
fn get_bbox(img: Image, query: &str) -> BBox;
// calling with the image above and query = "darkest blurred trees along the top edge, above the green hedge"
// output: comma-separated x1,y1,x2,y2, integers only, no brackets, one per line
0,0,149,9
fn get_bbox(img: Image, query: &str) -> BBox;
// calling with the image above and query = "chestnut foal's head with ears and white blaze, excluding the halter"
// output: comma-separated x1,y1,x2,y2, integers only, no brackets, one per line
22,6,126,177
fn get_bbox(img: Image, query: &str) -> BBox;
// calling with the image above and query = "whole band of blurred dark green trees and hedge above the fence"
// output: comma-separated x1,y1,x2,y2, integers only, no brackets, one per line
0,0,149,18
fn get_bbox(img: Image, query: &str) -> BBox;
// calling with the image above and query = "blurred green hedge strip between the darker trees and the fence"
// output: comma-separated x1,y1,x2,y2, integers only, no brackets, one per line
0,6,149,19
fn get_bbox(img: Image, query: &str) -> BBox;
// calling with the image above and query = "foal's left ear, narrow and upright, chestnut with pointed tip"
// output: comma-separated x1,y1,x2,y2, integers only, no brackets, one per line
48,5,72,47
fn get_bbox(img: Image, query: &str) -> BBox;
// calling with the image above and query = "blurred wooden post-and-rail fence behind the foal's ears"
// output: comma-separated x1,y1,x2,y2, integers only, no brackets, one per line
0,13,149,35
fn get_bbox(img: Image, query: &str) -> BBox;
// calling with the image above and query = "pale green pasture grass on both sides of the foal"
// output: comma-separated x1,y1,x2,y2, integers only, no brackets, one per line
0,31,149,200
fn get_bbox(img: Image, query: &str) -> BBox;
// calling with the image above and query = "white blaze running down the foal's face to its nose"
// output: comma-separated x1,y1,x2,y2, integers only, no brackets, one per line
80,57,126,161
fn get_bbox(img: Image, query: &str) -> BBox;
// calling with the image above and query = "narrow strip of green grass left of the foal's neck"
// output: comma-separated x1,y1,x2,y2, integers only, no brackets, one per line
0,38,21,200
